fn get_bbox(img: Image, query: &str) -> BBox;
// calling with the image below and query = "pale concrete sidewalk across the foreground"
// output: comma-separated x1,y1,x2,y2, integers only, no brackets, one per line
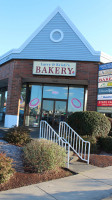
0,166,112,200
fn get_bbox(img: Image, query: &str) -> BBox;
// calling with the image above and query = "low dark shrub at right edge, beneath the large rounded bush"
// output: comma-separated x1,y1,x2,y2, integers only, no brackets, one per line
98,136,112,153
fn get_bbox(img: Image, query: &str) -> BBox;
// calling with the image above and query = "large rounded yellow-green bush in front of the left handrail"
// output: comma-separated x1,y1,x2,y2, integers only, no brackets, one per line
23,139,66,173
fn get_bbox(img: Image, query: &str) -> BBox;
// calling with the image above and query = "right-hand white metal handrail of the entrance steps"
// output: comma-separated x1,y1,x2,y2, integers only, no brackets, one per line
59,121,90,164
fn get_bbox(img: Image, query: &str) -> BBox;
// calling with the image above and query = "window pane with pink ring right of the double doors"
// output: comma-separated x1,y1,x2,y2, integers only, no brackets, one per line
68,87,84,115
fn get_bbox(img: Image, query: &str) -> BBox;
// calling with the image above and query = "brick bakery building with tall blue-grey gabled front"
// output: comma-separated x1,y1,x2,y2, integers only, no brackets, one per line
0,8,112,127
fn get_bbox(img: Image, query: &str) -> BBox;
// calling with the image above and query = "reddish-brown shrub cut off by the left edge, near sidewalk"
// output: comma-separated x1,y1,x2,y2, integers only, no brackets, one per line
0,153,15,184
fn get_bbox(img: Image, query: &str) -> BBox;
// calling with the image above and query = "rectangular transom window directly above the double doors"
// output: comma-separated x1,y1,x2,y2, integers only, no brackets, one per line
43,86,68,99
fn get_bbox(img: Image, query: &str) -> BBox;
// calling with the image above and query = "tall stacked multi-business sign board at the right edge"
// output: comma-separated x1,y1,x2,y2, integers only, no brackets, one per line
97,63,112,113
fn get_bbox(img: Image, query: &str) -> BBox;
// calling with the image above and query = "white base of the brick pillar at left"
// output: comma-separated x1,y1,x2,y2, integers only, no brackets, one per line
4,114,19,128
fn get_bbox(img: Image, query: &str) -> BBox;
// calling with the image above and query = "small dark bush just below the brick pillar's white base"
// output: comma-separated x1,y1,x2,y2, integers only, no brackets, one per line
4,126,31,146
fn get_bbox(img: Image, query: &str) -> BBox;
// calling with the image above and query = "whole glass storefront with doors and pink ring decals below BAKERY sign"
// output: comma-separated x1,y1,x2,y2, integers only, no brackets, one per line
23,85,84,127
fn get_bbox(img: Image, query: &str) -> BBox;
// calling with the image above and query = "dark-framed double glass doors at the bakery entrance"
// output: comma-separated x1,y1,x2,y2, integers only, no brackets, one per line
42,99,67,127
